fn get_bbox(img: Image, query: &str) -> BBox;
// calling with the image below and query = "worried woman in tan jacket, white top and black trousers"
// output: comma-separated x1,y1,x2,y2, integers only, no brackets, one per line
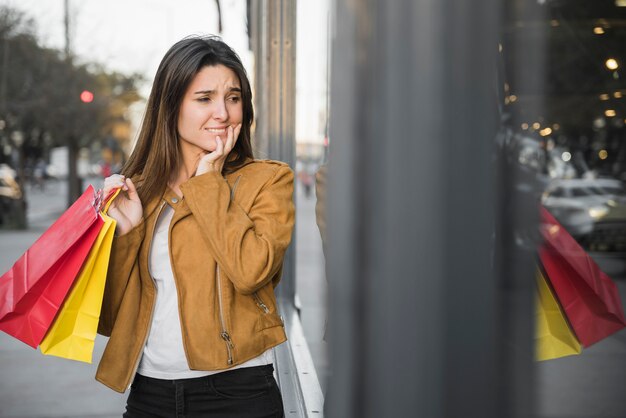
96,37,294,418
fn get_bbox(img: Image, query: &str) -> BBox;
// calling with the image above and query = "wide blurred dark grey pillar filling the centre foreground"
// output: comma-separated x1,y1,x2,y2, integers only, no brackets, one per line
327,0,533,418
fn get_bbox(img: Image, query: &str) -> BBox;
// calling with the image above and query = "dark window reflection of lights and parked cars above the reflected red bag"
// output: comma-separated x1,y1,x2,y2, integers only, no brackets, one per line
501,0,626,275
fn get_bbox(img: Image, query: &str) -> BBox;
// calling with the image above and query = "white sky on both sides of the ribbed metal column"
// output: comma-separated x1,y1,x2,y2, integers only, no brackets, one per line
0,0,329,148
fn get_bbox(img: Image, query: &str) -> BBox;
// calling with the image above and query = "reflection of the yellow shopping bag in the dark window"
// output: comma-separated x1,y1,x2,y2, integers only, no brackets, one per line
535,270,582,361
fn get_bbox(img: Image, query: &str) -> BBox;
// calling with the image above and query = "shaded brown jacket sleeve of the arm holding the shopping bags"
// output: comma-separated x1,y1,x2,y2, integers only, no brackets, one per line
98,220,145,337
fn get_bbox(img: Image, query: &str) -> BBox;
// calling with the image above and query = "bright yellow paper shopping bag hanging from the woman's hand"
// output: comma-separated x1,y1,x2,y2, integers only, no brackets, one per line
39,192,118,363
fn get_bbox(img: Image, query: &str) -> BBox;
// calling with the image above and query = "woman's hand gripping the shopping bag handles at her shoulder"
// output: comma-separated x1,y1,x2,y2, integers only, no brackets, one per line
103,174,143,236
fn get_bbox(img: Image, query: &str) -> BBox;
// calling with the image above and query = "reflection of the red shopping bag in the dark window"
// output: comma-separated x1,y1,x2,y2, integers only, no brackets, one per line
539,208,626,347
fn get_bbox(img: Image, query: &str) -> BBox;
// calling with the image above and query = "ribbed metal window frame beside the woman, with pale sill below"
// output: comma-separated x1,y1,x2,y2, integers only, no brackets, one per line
250,0,324,417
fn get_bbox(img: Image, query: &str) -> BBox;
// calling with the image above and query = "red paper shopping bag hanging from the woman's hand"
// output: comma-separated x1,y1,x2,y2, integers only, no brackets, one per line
0,186,104,348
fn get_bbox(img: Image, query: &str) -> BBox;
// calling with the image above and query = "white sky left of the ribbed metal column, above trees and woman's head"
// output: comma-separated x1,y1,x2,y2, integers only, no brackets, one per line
0,0,251,85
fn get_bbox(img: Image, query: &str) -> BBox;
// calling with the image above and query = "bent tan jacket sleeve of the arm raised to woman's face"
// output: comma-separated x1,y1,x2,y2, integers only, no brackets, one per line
181,165,295,294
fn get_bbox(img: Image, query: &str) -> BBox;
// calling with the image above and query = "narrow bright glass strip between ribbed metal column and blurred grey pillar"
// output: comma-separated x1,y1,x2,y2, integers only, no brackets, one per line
294,0,331,396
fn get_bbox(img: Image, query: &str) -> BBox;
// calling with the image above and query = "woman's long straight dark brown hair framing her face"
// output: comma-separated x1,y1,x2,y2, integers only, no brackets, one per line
122,36,254,204
